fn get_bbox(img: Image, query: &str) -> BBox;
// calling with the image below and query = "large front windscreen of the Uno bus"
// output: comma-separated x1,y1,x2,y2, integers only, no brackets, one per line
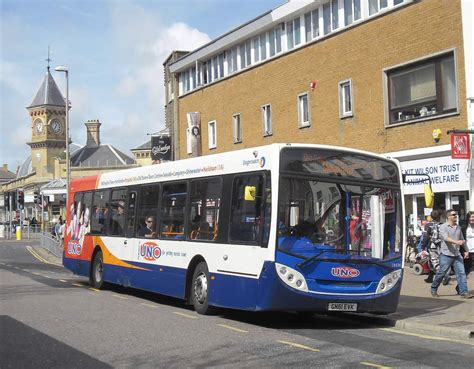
277,149,402,260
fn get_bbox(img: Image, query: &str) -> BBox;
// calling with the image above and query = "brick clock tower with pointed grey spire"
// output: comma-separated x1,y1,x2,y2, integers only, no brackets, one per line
26,65,66,180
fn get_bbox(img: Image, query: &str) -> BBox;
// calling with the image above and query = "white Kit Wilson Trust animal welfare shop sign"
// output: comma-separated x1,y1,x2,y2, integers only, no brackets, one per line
400,156,469,195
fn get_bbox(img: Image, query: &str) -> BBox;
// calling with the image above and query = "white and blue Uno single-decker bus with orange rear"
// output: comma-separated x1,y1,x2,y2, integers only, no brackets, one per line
63,144,405,314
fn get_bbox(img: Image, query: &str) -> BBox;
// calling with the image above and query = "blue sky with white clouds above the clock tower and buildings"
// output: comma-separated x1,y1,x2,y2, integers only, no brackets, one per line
0,0,285,172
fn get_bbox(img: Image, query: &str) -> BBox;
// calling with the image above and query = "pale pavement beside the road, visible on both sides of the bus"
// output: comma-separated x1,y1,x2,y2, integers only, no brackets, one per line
29,245,474,345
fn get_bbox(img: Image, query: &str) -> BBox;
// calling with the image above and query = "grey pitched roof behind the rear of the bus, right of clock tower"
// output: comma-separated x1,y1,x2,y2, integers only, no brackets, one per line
71,144,135,167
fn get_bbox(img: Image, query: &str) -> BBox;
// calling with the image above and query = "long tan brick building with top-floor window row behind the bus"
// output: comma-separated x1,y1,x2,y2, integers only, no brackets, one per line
167,0,474,224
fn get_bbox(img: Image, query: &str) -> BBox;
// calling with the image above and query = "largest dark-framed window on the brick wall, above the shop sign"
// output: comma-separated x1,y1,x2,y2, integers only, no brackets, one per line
386,52,458,124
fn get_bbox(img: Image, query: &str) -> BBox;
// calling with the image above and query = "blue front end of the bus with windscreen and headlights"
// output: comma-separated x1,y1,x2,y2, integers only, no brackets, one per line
266,146,404,314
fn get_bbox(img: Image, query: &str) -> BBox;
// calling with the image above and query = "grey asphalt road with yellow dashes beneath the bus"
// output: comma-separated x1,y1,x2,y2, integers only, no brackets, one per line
0,241,474,368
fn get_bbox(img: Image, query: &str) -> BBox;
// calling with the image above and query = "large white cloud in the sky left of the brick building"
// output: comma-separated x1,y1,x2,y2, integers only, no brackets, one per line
104,3,210,148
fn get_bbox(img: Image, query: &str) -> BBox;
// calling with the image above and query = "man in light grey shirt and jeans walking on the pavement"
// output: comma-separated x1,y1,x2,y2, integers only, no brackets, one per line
431,209,473,299
